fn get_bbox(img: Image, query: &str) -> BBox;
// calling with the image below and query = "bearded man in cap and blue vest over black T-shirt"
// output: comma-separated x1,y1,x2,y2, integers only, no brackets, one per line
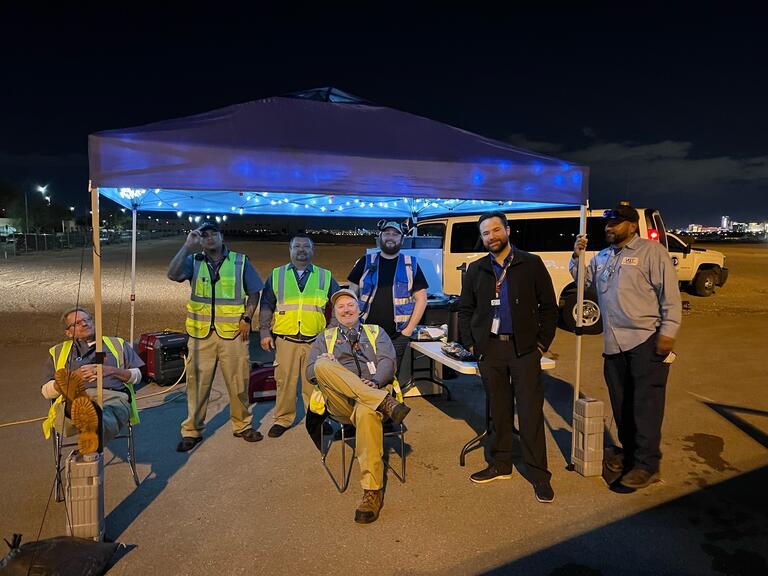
347,222,429,370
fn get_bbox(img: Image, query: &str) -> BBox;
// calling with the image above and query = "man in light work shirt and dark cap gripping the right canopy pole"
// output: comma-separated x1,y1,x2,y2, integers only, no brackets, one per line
569,203,682,491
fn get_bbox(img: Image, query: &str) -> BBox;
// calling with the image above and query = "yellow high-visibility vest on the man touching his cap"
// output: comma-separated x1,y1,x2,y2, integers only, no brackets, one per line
186,251,247,340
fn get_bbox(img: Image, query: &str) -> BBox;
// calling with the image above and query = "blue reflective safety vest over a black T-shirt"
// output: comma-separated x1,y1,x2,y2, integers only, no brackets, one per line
360,252,418,332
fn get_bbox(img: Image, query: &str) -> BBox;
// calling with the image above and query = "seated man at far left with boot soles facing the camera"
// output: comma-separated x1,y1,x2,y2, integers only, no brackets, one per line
41,308,144,454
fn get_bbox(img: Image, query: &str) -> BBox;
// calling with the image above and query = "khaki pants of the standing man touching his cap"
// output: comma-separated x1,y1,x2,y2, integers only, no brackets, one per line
181,331,253,438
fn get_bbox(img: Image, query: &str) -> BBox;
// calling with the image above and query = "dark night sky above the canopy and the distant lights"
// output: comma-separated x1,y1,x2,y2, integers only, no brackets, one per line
0,9,768,227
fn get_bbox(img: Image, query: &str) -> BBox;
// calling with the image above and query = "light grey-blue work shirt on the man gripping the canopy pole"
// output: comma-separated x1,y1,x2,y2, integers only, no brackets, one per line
569,236,683,354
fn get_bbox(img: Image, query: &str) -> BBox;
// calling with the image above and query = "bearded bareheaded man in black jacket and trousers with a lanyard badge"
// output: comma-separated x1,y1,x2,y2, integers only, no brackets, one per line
459,212,558,502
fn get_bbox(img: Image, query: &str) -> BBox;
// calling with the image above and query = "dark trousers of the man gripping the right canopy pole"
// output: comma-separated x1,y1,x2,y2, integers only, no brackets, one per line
603,335,669,472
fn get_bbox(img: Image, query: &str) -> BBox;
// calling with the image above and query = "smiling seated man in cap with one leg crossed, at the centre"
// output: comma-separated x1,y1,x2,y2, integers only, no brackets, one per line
307,290,410,524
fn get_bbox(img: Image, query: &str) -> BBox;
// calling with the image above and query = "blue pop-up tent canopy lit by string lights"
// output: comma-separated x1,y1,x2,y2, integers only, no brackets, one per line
88,88,588,218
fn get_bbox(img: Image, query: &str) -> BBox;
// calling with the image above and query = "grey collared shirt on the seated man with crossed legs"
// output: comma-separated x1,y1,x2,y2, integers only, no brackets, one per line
307,324,397,387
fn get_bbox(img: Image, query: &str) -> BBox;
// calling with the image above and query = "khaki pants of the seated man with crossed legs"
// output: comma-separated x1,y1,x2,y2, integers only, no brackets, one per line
315,359,388,490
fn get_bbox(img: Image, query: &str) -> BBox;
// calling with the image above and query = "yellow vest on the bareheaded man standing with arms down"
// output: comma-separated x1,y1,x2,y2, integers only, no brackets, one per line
272,265,331,336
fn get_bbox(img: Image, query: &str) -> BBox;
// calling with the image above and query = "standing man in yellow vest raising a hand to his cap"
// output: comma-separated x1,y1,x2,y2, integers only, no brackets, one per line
168,222,263,452
